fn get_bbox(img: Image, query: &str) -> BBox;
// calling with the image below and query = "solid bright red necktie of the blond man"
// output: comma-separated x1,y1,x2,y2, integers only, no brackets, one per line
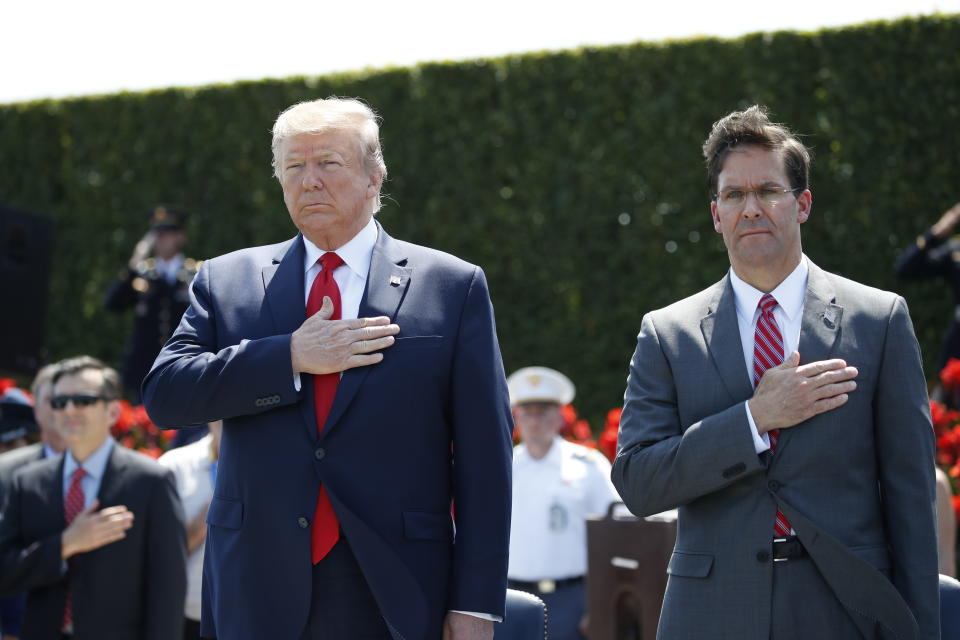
307,251,343,564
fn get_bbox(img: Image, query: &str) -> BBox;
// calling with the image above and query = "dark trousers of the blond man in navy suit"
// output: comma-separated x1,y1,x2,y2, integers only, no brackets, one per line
300,531,392,640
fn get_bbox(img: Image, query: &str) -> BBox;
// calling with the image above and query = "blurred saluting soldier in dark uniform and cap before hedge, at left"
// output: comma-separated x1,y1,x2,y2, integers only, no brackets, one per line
103,205,200,402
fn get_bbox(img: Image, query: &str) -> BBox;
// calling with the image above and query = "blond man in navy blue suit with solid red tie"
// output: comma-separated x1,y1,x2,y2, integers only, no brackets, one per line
144,98,512,640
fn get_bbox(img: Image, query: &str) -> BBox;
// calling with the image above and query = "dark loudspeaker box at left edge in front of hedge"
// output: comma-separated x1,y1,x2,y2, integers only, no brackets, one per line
0,204,53,376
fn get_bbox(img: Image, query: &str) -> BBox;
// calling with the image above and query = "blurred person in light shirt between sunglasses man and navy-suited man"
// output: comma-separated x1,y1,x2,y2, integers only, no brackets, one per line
158,420,223,640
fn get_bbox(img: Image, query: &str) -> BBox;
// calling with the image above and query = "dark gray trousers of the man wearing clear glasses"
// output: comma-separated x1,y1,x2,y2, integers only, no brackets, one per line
770,556,863,640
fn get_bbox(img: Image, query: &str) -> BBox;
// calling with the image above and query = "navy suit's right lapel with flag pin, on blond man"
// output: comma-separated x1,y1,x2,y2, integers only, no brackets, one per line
322,223,413,437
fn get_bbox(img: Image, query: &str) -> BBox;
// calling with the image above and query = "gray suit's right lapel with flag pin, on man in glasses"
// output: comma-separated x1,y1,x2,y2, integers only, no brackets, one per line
774,258,843,460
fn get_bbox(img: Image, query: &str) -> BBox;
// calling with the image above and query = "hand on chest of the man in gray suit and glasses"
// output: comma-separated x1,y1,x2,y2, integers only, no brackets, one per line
748,351,859,433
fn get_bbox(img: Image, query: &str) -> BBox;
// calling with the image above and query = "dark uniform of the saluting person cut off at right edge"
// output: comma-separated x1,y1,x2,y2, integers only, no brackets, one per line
895,231,960,371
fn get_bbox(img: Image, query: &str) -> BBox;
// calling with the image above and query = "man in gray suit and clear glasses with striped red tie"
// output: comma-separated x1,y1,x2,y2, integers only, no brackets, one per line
613,106,940,640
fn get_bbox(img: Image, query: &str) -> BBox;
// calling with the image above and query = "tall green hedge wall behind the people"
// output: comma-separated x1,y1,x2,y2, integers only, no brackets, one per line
0,15,960,424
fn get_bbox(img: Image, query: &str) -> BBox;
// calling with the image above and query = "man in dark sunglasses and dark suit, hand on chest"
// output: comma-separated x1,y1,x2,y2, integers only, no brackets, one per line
0,356,186,640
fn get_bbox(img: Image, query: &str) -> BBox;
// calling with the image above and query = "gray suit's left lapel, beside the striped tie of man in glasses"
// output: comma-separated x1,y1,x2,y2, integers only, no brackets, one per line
700,275,753,402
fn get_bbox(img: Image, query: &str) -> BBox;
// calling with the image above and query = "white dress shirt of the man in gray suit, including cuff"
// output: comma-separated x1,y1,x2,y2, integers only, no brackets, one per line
730,256,809,453
